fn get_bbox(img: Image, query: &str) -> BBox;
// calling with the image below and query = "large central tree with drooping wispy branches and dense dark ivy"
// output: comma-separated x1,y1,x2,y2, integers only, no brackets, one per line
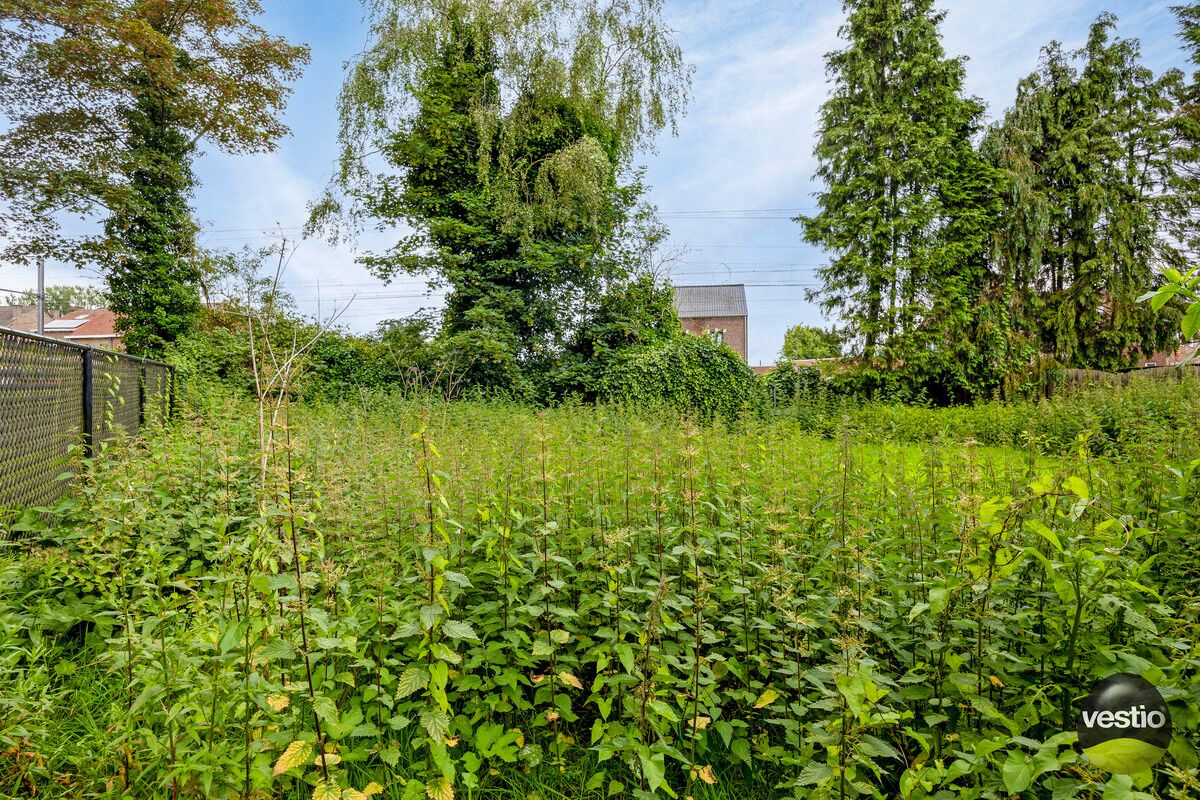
313,0,690,389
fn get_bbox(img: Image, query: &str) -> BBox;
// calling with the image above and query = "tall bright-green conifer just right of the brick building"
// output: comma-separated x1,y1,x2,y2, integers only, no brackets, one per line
798,0,995,398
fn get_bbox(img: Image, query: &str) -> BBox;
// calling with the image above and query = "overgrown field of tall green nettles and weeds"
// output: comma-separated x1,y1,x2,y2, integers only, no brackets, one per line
0,397,1200,800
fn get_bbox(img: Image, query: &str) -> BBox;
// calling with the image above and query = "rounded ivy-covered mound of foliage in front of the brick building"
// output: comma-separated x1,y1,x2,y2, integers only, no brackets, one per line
601,336,761,420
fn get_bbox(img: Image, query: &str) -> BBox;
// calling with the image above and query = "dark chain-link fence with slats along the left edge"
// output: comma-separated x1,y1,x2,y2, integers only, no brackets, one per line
0,329,174,515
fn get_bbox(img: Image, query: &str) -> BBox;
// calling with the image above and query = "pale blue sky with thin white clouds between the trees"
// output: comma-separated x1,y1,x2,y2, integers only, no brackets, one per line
0,0,1187,363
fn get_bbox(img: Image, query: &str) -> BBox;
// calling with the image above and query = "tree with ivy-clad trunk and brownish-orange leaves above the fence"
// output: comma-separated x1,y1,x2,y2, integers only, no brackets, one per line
0,0,308,353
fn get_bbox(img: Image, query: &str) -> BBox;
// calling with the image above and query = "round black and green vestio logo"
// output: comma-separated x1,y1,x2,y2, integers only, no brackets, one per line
1079,672,1171,775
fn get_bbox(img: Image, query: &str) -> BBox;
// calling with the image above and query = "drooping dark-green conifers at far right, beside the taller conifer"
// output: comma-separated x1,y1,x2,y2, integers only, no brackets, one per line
983,14,1195,369
